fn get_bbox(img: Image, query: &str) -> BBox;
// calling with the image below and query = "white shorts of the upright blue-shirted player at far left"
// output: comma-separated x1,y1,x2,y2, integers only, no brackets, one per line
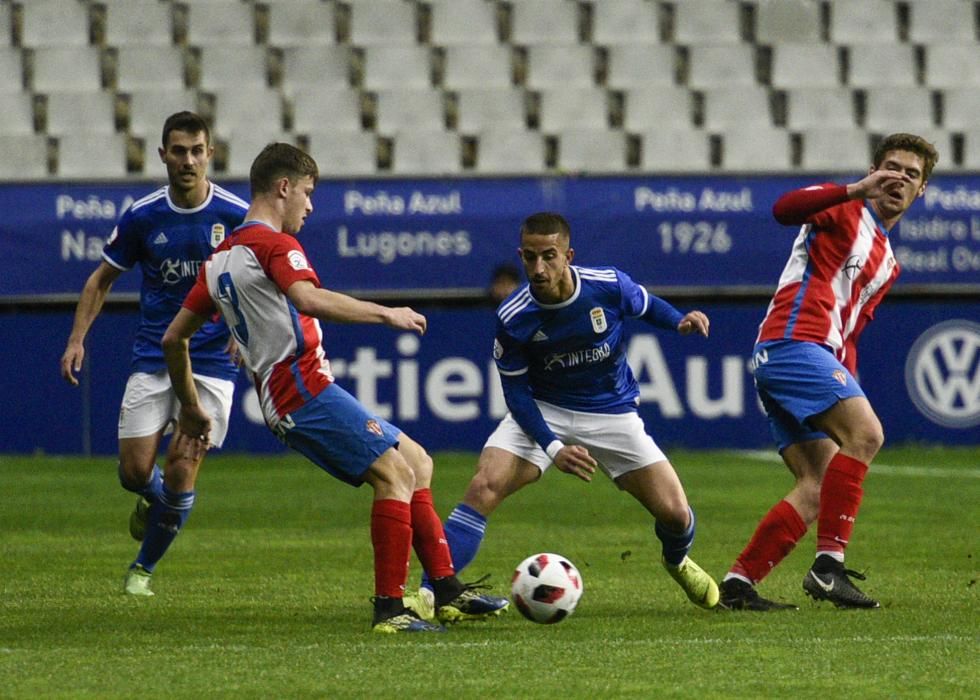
119,370,235,447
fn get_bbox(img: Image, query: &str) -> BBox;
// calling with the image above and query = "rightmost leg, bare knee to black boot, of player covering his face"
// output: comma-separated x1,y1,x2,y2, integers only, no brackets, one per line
803,396,884,608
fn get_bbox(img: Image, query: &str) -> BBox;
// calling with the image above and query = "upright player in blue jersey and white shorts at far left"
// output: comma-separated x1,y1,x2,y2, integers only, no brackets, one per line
61,112,248,596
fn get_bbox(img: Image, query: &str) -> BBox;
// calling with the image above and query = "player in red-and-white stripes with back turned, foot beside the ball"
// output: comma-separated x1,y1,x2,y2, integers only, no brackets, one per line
163,143,509,633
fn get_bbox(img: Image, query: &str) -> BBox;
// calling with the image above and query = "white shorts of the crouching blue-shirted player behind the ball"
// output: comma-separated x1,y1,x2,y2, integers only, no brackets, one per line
484,401,667,479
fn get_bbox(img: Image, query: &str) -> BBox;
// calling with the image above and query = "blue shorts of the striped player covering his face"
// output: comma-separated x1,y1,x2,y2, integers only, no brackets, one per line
752,340,864,452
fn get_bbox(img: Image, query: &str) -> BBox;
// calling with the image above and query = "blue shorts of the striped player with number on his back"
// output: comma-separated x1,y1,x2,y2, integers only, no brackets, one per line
277,384,401,486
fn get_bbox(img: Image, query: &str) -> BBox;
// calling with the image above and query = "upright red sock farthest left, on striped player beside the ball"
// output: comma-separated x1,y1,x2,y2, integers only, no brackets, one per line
371,498,412,598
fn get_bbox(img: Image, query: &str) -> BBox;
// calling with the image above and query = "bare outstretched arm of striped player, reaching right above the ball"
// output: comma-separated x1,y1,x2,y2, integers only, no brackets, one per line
286,280,426,334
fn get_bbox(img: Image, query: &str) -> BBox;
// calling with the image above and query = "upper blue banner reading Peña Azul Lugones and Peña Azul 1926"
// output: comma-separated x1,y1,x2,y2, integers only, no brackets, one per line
0,175,980,300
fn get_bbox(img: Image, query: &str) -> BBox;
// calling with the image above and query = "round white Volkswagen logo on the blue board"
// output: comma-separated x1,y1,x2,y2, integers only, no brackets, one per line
905,320,980,428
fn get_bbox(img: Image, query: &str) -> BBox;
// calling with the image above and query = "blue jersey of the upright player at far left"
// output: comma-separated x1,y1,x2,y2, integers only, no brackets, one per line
102,183,248,379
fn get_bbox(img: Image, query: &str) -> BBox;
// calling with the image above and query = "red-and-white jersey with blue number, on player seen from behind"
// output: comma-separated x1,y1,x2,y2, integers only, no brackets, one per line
184,221,333,429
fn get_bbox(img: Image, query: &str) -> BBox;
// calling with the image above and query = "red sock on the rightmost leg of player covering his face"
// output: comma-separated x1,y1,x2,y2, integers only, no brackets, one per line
817,452,868,554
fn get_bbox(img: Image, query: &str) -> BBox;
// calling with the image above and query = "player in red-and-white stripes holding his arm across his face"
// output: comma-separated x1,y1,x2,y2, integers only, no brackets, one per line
721,134,938,611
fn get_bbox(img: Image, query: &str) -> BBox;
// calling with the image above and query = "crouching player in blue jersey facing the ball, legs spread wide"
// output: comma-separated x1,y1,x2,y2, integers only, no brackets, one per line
410,212,718,615
